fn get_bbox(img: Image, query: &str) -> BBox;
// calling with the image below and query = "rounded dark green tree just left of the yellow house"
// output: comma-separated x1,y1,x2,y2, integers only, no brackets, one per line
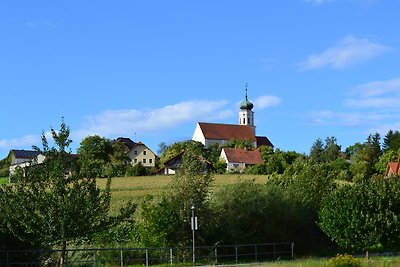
77,135,112,177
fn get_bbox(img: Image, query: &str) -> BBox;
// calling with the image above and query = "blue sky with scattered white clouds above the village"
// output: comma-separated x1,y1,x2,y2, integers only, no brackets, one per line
0,0,400,158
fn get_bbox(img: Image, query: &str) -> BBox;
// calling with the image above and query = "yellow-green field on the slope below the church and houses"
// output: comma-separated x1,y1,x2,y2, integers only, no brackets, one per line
97,174,267,213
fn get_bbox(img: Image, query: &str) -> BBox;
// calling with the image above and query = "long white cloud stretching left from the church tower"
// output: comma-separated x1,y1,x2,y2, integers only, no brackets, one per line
74,100,232,138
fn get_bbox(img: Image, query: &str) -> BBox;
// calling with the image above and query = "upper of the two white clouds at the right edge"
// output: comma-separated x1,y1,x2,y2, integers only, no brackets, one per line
345,78,400,110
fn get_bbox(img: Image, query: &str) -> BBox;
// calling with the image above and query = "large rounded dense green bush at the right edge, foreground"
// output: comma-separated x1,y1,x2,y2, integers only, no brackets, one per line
319,177,400,256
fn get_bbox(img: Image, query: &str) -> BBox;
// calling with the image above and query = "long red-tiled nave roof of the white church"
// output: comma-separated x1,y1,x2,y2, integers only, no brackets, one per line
199,122,257,142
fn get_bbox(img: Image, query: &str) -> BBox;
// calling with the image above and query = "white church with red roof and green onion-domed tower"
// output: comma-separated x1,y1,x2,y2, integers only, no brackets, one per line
192,85,274,148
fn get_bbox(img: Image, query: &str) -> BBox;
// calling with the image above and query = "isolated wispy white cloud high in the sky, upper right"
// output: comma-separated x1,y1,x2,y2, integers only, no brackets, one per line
299,35,389,70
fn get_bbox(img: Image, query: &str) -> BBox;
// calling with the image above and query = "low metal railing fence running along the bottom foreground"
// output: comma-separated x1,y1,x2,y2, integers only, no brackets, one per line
0,242,294,267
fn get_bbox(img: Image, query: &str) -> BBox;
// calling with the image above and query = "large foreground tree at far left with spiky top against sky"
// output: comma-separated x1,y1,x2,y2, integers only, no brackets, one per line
0,121,115,266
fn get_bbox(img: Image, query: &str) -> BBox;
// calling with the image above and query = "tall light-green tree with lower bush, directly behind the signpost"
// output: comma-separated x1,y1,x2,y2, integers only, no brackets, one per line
139,151,213,246
